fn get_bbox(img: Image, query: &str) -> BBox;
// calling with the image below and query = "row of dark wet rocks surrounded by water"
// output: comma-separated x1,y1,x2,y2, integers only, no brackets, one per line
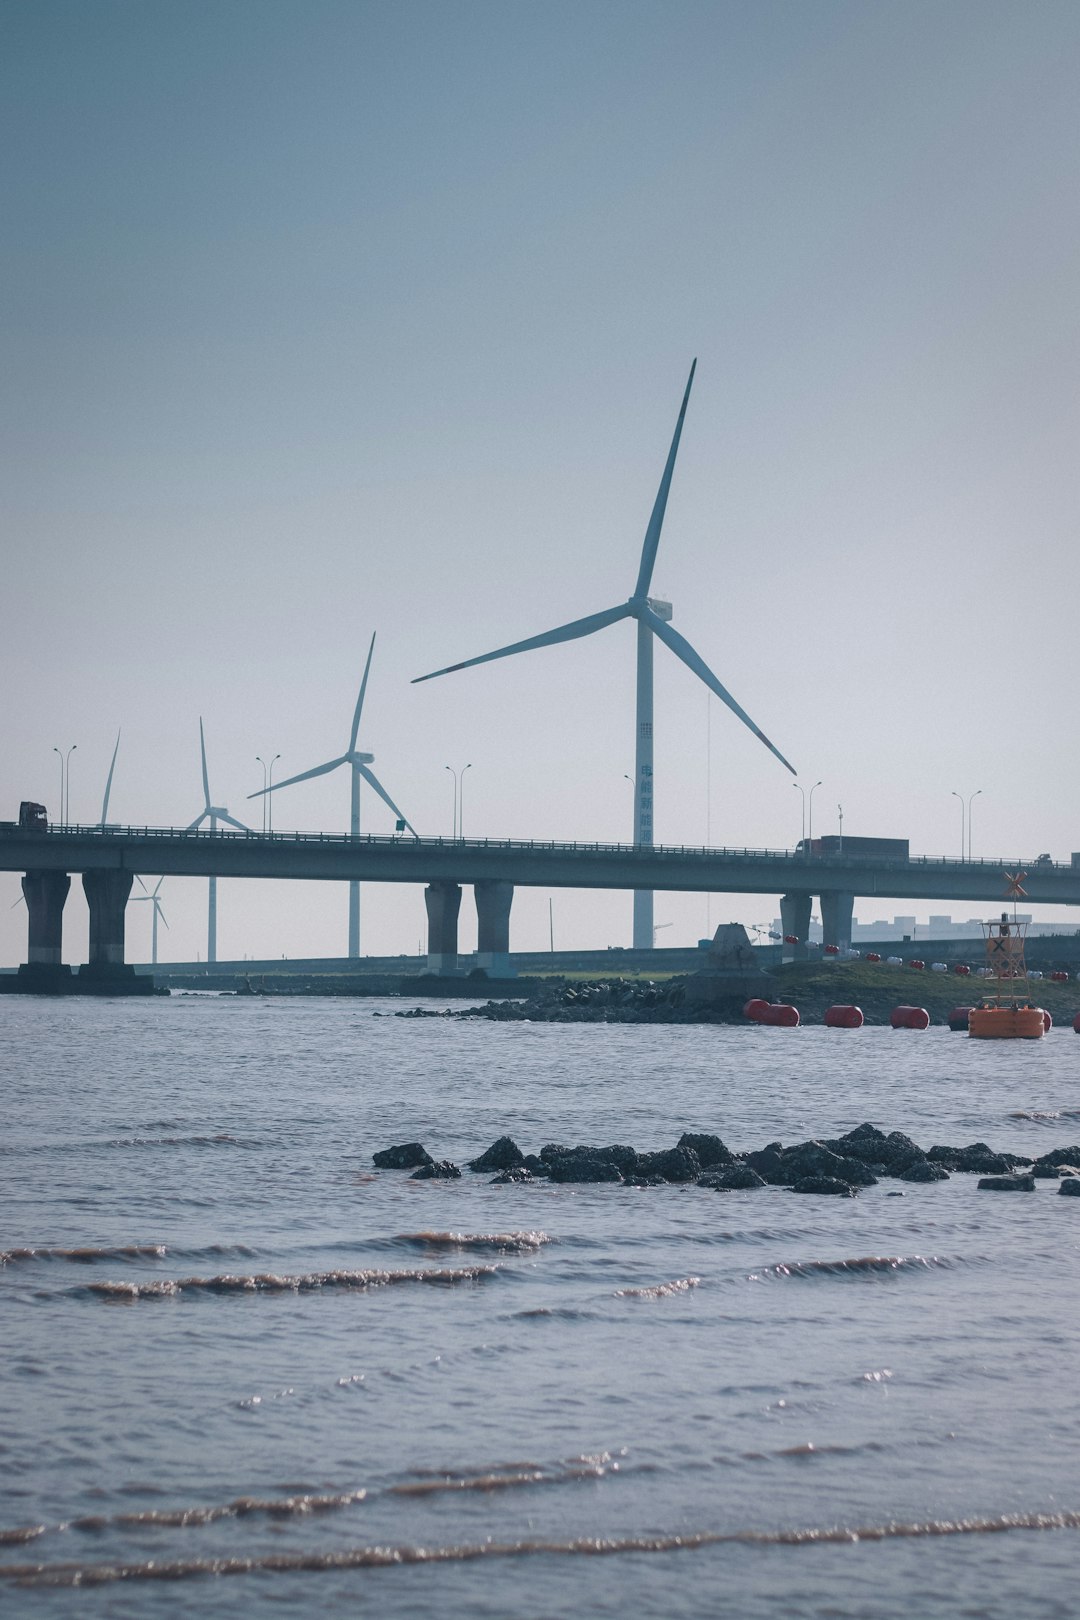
367,1123,1080,1197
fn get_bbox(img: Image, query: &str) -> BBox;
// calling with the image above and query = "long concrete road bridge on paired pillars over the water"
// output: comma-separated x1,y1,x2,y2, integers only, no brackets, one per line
0,826,1080,988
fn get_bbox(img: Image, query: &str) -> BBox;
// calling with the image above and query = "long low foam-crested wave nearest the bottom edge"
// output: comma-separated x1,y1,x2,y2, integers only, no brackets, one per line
12,1511,1080,1586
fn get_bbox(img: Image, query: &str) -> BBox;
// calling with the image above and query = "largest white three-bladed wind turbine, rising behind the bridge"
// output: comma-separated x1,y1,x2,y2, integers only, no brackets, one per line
413,360,797,951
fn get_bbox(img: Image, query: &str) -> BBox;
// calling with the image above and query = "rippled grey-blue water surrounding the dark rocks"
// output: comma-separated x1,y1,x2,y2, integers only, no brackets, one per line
0,996,1080,1620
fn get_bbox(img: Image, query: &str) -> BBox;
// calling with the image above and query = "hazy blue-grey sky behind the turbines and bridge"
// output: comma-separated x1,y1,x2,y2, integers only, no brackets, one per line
0,0,1080,966
